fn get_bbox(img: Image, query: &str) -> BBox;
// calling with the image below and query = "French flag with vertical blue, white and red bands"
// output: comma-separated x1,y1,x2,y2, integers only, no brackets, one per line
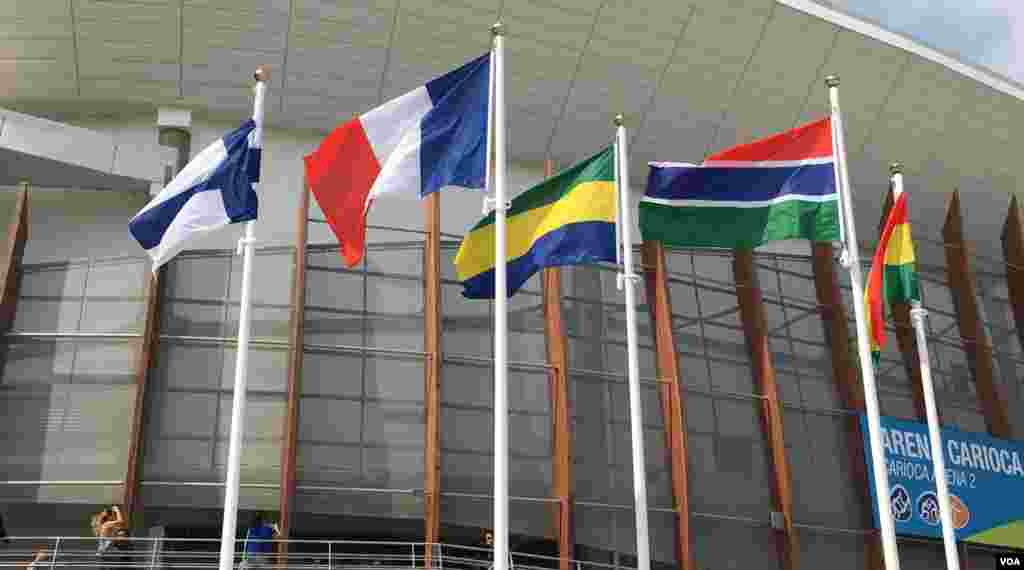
305,53,490,267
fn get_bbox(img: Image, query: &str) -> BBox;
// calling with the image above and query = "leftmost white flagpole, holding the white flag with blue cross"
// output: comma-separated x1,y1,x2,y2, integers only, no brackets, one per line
220,68,270,570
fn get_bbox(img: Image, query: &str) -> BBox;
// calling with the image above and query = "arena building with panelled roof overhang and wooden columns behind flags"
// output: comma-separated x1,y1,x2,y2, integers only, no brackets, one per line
0,0,1024,570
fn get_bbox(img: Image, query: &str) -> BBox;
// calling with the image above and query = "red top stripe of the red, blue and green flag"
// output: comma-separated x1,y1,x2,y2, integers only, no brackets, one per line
706,117,833,162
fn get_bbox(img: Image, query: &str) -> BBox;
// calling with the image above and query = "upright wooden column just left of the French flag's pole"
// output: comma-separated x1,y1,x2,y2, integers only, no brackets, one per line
423,192,441,568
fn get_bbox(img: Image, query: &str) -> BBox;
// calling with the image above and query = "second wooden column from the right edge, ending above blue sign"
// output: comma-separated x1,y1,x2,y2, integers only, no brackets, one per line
942,191,1013,439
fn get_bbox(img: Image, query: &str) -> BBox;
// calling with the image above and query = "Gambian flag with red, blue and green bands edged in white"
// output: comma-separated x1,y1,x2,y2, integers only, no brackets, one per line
640,118,839,249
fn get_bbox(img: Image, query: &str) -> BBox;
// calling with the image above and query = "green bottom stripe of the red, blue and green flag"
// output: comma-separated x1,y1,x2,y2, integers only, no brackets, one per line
640,200,839,249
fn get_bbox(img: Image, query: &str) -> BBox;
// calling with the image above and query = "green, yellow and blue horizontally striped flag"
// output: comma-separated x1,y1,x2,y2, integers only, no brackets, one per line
455,146,615,299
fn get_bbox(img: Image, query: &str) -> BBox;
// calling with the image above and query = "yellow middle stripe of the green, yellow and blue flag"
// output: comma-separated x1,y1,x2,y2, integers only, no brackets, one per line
455,180,615,281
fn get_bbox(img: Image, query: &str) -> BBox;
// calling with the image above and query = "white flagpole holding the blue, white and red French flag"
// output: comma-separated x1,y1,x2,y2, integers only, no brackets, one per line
490,21,509,570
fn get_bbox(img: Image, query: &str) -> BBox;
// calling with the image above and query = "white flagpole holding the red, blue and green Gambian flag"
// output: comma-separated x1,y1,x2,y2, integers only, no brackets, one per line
825,76,899,570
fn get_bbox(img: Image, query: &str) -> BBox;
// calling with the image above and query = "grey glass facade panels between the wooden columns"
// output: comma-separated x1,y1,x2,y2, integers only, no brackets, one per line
0,232,1024,569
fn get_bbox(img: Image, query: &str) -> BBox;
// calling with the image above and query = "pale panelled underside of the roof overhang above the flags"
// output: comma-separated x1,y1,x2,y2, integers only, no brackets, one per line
0,0,1024,260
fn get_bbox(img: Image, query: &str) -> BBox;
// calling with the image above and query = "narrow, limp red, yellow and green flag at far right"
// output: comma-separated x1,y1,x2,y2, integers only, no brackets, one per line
864,192,921,366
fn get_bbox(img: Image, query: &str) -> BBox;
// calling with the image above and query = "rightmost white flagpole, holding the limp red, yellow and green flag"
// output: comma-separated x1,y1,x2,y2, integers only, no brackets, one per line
889,163,959,570
